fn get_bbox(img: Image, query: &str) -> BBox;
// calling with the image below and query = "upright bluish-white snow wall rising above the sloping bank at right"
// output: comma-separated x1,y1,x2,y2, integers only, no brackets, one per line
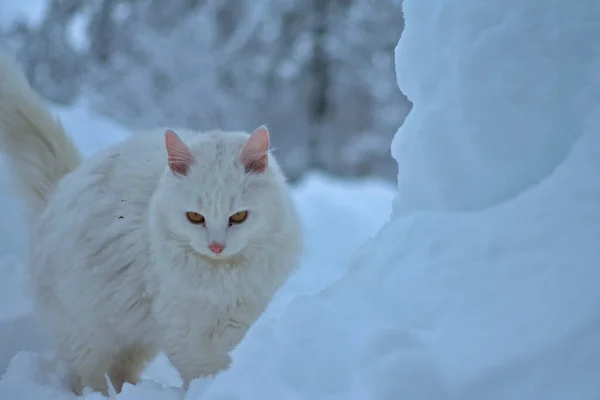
393,0,600,214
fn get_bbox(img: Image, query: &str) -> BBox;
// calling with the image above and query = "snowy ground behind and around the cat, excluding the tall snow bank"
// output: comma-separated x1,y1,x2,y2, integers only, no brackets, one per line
0,103,395,400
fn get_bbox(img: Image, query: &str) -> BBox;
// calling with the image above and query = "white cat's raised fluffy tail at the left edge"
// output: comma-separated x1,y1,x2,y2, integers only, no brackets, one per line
0,51,81,214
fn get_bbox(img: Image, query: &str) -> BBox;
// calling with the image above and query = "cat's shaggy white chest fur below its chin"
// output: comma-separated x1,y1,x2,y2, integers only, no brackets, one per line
153,248,275,352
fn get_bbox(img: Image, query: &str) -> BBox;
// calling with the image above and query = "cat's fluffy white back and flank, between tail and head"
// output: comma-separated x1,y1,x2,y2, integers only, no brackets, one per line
29,131,197,336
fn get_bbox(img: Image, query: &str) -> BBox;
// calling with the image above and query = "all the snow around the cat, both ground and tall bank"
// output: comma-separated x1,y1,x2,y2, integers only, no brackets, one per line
0,0,600,400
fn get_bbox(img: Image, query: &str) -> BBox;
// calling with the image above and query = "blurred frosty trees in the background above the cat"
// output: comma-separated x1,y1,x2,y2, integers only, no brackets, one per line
1,0,411,179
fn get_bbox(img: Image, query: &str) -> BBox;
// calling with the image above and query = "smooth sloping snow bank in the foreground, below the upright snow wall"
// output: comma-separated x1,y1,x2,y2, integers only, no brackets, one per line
190,133,600,400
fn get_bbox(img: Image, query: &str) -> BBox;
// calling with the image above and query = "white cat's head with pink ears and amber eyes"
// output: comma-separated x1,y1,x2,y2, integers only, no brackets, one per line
153,126,285,259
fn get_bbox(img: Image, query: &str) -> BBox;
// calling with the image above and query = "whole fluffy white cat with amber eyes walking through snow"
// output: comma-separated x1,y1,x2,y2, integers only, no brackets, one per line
0,50,302,394
